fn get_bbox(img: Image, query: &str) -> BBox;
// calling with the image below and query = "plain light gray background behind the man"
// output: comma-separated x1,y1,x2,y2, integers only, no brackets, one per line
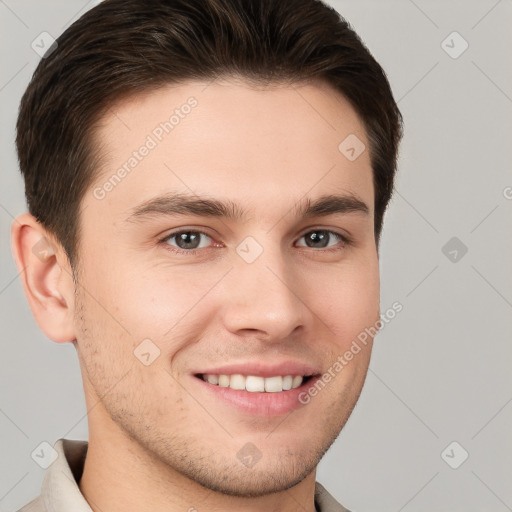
0,0,512,512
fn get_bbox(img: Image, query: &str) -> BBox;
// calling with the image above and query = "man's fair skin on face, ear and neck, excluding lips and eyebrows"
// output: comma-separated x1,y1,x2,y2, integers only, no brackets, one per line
12,79,379,512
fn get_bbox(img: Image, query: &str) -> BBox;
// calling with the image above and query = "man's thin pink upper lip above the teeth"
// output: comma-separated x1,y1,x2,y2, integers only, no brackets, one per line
193,361,320,377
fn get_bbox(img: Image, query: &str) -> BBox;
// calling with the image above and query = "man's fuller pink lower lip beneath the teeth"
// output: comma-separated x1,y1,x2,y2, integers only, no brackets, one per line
192,375,321,416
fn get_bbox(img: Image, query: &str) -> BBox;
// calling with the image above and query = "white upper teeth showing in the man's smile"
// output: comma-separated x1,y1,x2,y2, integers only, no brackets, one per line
202,373,303,393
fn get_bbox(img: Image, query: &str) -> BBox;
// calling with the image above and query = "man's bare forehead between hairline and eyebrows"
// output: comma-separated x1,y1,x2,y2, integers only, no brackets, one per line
87,80,373,220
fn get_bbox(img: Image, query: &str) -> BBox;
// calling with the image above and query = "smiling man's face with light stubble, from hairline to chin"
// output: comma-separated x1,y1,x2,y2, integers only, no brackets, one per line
75,81,379,496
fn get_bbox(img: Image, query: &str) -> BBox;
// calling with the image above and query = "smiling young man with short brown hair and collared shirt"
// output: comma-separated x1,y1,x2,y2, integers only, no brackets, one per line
12,0,401,512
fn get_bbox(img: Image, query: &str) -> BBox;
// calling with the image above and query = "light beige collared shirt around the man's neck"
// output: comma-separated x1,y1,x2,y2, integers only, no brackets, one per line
18,439,350,512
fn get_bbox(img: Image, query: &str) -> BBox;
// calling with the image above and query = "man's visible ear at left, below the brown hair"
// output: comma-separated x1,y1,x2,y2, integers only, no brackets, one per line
11,213,76,343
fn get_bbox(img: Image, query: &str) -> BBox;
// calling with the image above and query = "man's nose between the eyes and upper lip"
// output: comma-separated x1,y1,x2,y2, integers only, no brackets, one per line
221,243,311,342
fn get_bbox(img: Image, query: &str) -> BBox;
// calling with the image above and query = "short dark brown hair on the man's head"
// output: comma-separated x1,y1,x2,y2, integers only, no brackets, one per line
16,0,402,268
